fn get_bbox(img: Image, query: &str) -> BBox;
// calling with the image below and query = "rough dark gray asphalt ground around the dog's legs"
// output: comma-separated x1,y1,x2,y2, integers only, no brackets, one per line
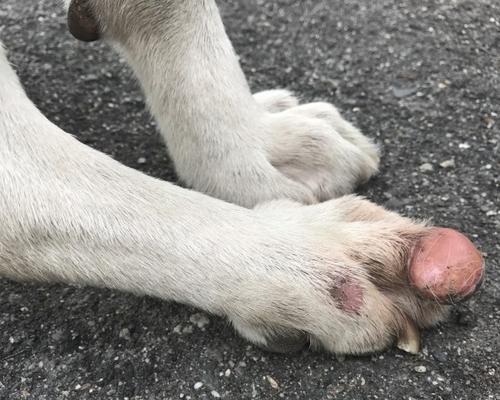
0,0,500,400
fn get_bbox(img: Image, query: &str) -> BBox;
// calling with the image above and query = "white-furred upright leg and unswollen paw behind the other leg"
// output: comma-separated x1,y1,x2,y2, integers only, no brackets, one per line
66,0,379,207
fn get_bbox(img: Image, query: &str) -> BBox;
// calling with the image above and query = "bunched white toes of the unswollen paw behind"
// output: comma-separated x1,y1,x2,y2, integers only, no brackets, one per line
254,90,380,201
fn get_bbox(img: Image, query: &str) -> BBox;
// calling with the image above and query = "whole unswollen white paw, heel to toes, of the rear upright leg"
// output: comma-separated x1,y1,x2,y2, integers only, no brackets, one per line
175,90,380,207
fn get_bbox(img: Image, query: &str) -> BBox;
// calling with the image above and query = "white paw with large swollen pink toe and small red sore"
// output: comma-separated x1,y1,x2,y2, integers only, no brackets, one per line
231,196,484,354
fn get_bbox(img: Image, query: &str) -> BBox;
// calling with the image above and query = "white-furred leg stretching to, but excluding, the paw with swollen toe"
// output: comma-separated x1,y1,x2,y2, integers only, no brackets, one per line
0,41,282,314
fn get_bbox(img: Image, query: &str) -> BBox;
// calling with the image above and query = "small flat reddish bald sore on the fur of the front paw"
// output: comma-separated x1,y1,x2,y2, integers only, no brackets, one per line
329,276,364,315
